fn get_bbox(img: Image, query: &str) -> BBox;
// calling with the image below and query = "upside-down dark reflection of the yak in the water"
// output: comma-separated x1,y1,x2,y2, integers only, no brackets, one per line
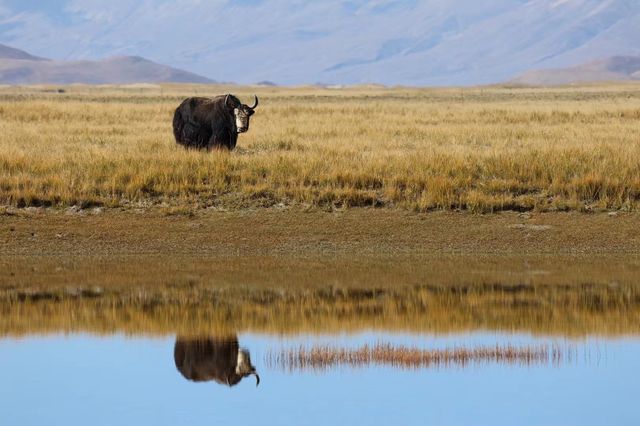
173,336,260,386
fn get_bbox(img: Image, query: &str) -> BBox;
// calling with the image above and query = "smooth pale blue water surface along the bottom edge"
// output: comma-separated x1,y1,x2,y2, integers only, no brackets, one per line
0,333,640,426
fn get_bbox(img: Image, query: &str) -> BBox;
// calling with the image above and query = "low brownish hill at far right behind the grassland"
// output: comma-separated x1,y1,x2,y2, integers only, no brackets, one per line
511,55,640,86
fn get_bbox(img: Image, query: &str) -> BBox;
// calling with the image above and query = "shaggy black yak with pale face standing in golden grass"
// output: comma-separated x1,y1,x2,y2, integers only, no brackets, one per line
173,94,258,150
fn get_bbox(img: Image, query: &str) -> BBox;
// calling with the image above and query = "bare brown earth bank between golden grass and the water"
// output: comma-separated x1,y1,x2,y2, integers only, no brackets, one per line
0,209,640,256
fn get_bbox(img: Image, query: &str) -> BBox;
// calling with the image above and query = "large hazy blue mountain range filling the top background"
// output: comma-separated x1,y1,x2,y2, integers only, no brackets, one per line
0,0,640,85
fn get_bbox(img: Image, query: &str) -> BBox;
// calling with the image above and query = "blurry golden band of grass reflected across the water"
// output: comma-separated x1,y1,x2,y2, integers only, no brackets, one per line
0,284,640,335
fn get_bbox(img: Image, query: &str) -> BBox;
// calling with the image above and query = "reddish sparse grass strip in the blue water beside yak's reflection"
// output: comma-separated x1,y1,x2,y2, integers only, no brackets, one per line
265,343,574,371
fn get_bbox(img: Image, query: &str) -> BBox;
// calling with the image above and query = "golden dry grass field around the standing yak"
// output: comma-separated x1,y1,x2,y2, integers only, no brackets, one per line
0,85,640,212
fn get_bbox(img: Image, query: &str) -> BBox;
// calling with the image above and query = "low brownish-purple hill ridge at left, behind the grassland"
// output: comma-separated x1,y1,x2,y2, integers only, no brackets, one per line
0,45,213,84
